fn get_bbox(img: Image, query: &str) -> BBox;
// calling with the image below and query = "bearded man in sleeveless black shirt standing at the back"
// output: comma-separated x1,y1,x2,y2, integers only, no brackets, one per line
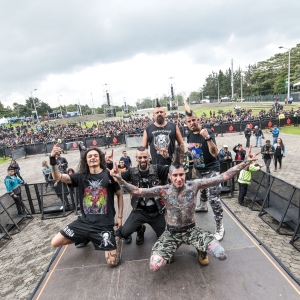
142,99,184,166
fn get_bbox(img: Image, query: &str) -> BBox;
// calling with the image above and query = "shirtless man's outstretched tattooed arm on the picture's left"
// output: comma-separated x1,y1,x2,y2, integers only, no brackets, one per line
107,163,165,198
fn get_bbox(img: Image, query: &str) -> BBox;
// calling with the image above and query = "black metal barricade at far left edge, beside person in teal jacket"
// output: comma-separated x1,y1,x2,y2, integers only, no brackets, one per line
0,187,32,236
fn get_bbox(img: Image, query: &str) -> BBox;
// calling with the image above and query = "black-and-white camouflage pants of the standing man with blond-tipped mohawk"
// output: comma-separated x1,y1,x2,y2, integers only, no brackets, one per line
196,171,223,221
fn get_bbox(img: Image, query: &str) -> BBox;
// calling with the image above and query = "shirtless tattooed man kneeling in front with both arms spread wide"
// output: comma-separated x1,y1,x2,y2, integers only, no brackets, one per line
110,148,257,272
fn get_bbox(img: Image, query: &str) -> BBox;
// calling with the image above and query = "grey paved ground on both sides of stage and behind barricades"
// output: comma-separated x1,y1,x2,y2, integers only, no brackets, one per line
0,129,300,299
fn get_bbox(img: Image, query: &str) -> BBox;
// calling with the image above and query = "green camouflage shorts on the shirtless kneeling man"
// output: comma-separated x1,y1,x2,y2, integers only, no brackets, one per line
151,226,215,260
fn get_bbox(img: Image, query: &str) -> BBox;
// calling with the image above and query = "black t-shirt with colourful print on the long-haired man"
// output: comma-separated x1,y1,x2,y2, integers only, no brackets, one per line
70,170,120,227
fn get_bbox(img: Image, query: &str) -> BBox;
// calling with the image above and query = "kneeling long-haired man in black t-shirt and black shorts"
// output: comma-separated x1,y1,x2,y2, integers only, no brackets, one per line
50,144,123,267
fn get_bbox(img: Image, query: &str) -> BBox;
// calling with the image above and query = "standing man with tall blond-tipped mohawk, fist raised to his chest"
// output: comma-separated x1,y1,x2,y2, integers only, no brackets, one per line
185,102,225,241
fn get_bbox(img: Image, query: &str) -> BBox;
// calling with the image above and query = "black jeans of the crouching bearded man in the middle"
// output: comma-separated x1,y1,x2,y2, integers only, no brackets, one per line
120,210,166,238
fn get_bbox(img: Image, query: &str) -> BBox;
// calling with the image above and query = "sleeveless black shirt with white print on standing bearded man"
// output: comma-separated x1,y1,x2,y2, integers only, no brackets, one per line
146,122,176,166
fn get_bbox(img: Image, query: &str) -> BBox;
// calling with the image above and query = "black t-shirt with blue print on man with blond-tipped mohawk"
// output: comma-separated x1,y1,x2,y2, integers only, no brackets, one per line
187,128,220,172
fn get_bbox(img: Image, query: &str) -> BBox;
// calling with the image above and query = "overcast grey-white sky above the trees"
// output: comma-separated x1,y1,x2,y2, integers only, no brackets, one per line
0,0,300,107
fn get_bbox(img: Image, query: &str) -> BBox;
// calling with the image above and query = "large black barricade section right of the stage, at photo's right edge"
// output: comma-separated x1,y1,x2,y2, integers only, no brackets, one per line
258,171,300,235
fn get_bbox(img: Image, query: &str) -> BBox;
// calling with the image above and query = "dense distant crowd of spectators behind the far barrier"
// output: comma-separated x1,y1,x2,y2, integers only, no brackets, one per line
0,102,300,148
